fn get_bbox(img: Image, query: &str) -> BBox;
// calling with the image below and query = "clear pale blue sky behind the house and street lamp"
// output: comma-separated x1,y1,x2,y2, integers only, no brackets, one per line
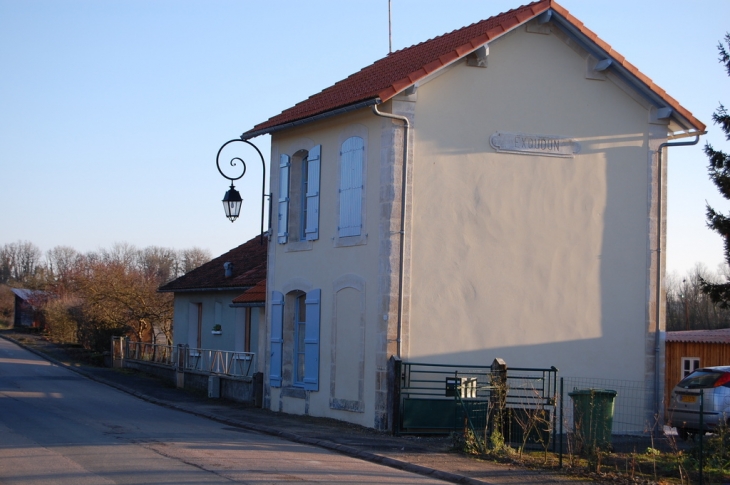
0,0,730,274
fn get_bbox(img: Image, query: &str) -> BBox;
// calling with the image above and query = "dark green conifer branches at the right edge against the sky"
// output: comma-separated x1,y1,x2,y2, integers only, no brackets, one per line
702,33,730,308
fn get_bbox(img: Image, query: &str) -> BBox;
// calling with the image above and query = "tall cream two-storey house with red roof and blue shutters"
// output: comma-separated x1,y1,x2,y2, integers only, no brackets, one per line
242,0,704,429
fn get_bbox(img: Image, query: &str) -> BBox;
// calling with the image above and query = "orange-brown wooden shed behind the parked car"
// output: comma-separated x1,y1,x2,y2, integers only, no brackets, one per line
664,328,730,406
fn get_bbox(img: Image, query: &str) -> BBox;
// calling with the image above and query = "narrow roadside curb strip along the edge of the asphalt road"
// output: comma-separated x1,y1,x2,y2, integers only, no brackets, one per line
0,335,492,485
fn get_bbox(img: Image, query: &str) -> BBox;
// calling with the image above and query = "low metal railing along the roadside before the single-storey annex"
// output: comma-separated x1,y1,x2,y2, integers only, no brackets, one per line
112,337,256,377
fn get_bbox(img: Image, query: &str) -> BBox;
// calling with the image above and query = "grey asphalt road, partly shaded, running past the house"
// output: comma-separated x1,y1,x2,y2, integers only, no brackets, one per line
0,339,443,485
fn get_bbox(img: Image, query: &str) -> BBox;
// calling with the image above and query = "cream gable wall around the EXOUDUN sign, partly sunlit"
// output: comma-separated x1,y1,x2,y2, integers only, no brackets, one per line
407,27,649,379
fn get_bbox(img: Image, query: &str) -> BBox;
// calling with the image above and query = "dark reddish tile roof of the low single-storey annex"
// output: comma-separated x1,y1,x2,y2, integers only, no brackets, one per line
159,236,267,292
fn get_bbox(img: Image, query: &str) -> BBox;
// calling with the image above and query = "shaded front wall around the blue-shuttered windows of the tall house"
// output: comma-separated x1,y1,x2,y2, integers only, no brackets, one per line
269,109,381,426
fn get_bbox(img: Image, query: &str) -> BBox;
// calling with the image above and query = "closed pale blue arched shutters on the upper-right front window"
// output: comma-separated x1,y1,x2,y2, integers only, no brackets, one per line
338,136,365,237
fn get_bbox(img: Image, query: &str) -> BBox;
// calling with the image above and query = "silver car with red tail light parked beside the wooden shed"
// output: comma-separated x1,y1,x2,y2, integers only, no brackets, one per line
667,366,730,440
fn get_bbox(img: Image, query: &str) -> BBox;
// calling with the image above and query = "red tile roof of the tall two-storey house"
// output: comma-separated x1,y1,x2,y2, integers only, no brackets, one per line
241,0,705,139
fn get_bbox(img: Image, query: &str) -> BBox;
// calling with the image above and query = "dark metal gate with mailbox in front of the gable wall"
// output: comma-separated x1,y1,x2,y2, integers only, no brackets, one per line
394,359,558,450
